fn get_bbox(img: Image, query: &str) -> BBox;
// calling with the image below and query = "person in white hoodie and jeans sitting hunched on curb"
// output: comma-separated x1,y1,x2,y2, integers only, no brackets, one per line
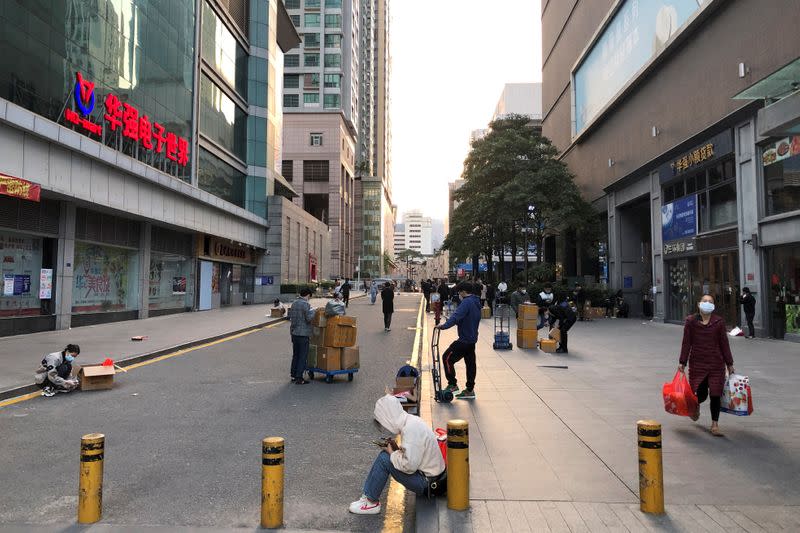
349,394,445,514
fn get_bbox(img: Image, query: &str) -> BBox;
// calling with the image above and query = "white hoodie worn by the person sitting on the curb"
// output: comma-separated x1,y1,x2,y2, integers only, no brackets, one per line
375,394,444,477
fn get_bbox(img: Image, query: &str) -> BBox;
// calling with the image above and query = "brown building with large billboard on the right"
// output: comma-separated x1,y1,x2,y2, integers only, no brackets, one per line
541,0,800,340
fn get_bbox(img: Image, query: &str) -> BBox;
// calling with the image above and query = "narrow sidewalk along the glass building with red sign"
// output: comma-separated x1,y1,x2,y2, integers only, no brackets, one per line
0,293,344,400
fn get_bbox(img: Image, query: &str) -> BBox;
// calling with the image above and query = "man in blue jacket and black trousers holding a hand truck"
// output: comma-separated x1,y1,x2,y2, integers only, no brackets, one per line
436,281,481,400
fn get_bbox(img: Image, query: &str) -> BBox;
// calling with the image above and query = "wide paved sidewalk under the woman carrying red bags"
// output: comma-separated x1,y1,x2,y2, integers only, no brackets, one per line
417,319,800,533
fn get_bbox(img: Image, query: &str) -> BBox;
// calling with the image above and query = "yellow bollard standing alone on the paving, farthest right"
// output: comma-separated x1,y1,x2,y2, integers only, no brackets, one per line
636,420,664,514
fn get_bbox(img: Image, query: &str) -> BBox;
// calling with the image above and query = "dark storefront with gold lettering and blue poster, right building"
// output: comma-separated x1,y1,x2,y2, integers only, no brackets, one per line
659,130,741,325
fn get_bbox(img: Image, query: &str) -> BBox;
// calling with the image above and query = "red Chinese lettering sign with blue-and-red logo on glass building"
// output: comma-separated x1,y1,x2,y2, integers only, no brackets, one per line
64,72,189,167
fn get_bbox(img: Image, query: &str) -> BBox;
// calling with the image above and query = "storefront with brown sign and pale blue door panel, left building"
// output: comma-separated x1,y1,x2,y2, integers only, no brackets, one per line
197,235,259,311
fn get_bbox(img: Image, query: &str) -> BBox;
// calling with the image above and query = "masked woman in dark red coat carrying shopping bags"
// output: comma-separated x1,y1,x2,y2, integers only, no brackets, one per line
678,294,734,437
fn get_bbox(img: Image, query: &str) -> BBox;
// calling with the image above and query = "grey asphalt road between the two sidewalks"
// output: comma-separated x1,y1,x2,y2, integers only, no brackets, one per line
0,294,419,531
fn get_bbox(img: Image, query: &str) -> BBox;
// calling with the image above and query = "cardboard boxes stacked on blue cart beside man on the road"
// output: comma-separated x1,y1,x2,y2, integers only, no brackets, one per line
307,309,359,372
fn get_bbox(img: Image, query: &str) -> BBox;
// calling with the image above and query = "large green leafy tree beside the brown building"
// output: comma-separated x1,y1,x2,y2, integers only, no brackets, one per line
442,116,598,277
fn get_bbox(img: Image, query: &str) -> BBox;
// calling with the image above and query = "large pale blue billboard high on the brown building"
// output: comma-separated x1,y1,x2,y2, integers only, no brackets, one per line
573,0,710,135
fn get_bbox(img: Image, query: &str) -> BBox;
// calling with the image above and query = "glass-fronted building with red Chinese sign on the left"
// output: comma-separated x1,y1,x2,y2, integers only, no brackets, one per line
0,0,328,335
